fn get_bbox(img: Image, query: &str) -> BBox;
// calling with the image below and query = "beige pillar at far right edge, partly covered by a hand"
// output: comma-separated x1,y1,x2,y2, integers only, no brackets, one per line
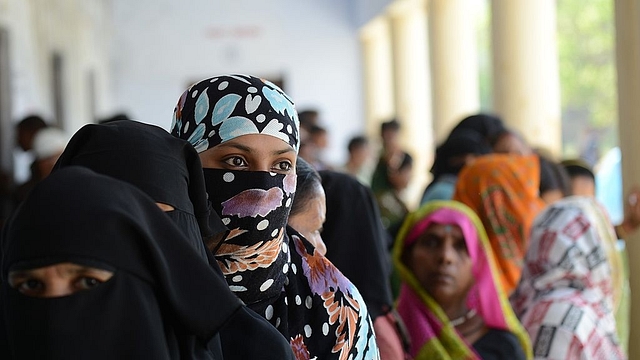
615,0,640,359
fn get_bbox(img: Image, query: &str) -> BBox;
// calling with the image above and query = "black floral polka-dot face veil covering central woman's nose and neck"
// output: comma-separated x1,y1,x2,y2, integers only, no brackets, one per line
204,169,296,306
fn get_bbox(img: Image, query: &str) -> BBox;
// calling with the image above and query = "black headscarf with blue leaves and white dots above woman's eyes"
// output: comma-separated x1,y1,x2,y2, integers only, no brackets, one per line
171,75,300,152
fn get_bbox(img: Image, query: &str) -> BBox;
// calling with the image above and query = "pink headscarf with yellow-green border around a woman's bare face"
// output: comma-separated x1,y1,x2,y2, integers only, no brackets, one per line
393,201,530,359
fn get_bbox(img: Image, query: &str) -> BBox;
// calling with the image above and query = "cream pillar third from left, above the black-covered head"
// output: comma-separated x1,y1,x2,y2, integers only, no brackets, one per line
428,0,480,142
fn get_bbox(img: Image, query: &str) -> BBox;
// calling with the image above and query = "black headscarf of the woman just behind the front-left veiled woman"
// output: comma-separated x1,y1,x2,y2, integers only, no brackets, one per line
55,120,226,257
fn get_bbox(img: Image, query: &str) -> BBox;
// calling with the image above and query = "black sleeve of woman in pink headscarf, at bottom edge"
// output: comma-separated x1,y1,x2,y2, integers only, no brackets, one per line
473,329,527,360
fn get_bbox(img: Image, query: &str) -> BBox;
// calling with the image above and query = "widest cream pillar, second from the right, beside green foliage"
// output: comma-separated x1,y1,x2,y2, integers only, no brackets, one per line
491,0,562,156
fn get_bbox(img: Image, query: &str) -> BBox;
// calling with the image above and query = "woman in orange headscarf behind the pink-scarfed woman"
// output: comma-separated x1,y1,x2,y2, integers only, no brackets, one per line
453,154,544,294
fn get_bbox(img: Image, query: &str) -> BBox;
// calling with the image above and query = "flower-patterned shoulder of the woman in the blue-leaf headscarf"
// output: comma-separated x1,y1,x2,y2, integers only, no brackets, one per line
285,226,379,359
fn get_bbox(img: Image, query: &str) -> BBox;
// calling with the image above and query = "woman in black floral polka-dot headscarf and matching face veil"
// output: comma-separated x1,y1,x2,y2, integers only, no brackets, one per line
171,75,379,359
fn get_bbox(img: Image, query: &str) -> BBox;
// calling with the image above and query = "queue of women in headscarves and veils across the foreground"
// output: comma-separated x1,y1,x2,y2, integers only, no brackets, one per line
0,75,626,360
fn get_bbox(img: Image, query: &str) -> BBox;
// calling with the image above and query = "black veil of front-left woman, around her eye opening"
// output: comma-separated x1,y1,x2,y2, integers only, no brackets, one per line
0,167,241,359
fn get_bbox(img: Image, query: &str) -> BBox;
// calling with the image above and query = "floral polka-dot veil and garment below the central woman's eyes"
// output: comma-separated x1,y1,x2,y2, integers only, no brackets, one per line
204,169,379,359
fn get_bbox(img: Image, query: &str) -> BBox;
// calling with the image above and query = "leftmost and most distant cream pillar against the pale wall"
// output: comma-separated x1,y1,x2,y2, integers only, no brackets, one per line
360,16,395,141
